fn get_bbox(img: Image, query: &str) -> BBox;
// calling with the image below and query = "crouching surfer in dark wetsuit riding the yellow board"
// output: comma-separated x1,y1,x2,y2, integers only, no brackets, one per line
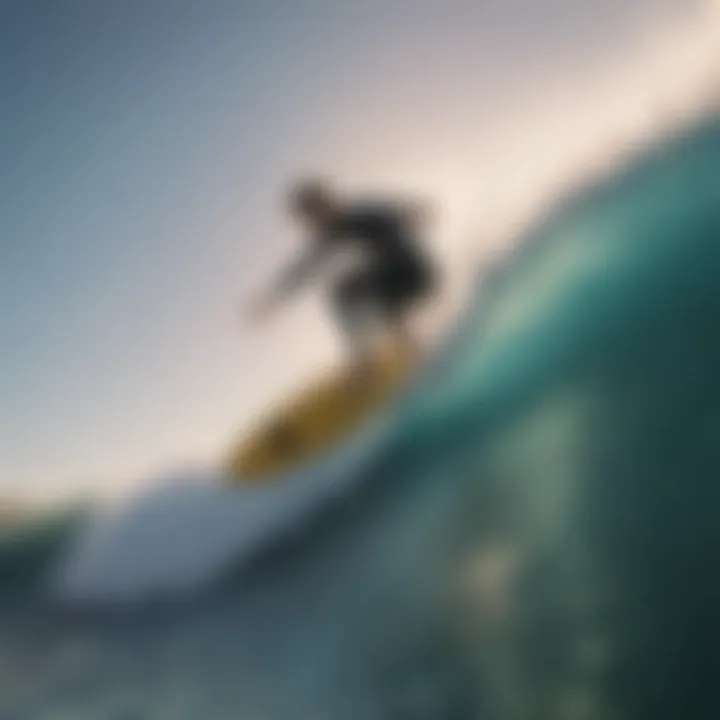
250,179,437,368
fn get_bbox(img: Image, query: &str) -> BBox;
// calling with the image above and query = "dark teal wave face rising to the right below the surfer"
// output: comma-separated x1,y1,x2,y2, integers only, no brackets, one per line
0,119,720,720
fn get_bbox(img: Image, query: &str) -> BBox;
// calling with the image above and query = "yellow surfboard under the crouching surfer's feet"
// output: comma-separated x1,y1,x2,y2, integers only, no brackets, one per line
227,353,414,484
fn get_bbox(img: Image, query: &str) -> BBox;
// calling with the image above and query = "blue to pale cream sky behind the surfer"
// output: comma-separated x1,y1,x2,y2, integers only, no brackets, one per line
0,0,720,498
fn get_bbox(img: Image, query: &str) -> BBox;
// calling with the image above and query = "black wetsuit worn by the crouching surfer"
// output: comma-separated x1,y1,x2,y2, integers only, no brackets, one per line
277,203,435,335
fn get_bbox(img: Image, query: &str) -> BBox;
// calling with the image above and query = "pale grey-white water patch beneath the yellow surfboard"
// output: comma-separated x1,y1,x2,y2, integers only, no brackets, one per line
52,417,389,604
